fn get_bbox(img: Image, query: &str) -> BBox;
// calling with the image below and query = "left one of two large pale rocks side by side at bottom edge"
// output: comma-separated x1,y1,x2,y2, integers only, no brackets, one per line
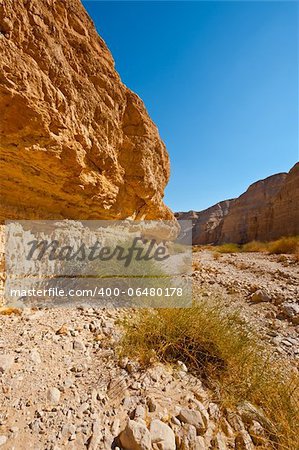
119,420,151,450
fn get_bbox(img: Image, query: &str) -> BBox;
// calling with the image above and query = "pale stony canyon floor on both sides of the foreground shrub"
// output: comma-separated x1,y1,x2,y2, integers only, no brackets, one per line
0,251,299,450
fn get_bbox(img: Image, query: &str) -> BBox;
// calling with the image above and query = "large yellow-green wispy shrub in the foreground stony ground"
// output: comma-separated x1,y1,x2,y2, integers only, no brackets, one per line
122,302,299,450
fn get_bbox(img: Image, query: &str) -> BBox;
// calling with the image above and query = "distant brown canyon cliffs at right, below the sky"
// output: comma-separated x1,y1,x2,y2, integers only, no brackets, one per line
175,163,299,244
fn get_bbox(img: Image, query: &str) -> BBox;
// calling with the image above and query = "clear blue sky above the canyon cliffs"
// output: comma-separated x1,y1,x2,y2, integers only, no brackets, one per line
83,1,298,211
